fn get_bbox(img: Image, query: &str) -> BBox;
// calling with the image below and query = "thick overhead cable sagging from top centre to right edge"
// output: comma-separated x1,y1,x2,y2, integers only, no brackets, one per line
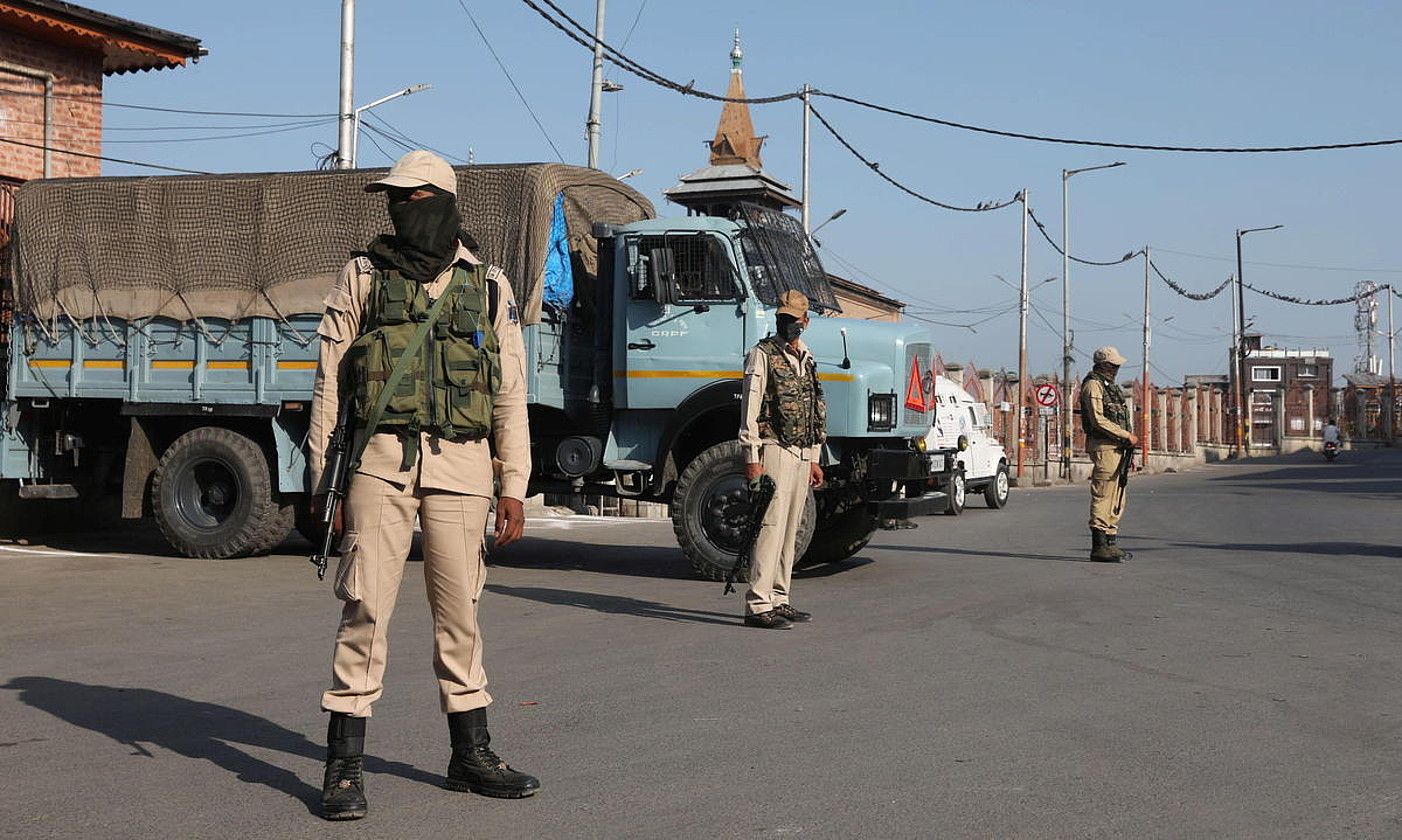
521,0,1402,154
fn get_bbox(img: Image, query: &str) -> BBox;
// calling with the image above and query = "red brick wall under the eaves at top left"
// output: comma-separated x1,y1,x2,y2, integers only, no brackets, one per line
0,31,102,181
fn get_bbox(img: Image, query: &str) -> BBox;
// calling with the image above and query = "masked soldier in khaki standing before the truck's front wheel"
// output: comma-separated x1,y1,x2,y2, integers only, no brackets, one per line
740,289,827,630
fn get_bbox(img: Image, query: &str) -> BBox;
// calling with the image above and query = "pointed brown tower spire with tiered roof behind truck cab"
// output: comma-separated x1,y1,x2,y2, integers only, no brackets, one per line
663,27,799,216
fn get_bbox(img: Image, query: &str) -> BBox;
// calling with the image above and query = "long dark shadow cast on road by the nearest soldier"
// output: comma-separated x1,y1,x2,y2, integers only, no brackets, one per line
0,676,442,813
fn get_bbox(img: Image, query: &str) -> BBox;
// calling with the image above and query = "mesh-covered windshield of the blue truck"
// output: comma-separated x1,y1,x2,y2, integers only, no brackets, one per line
739,205,841,311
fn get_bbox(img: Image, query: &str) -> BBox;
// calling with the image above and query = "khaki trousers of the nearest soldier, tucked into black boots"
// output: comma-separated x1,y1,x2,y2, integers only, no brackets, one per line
321,473,492,717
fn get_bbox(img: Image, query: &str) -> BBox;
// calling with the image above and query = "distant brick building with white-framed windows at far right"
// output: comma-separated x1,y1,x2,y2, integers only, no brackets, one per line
1238,334,1335,452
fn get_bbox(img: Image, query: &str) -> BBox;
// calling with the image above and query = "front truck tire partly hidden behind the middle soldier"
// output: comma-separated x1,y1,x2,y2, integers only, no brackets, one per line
672,440,817,581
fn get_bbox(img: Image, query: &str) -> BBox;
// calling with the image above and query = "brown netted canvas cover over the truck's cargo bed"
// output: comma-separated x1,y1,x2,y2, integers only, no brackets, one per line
15,164,653,324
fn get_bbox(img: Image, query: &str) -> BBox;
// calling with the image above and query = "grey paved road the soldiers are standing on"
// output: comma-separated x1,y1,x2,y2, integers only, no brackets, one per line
0,453,1402,837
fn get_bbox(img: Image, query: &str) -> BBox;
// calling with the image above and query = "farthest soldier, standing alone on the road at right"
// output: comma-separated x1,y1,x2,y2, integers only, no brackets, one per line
1081,346,1138,562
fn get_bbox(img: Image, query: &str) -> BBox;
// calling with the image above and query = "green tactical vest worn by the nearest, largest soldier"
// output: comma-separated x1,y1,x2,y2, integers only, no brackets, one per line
346,265,502,454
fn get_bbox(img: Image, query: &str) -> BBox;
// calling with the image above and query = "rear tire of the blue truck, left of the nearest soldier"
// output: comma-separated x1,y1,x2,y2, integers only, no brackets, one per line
151,426,294,560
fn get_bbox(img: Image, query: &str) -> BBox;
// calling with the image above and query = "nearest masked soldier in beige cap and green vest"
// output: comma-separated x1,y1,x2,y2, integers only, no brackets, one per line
310,151,540,819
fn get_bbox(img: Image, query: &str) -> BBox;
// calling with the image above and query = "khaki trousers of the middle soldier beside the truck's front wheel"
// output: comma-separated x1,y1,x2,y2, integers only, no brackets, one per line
744,440,809,616
